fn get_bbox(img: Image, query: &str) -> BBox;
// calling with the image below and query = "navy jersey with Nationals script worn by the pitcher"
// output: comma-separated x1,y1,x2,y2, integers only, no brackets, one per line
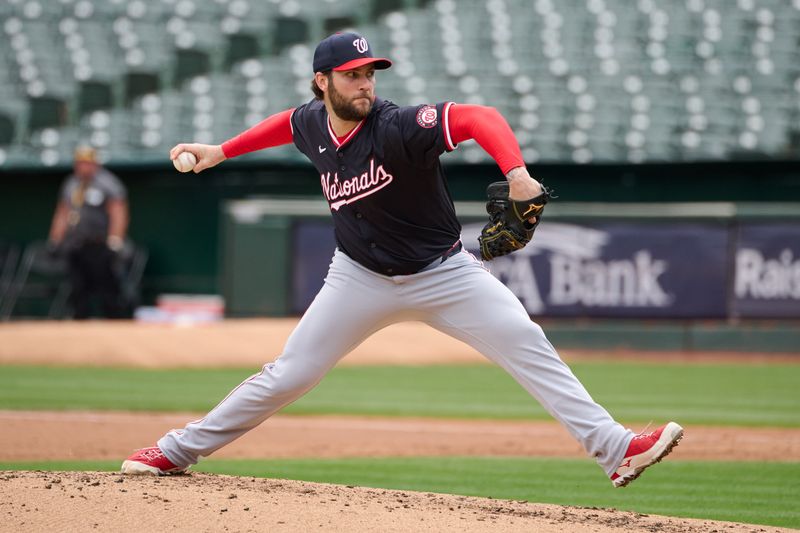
291,98,461,276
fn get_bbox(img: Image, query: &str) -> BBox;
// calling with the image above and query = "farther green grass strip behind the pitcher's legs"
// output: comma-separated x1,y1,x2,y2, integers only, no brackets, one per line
0,362,800,427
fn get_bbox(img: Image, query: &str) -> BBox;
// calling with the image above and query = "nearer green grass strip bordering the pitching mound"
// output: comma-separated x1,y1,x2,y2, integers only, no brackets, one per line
0,457,800,528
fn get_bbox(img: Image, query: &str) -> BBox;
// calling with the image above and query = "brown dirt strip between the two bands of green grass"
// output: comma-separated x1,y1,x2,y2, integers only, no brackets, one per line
0,411,800,464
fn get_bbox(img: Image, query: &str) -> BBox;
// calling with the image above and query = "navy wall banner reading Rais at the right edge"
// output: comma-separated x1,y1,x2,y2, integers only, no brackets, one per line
733,223,800,318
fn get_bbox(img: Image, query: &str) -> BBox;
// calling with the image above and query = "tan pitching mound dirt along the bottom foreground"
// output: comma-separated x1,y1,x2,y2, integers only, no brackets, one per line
0,472,789,533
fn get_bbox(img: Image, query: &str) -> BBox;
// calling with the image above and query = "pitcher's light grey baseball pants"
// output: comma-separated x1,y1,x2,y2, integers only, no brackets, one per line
158,250,633,475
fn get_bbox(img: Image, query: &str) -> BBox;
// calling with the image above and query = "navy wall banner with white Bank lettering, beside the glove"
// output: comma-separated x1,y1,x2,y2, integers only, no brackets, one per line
462,222,729,318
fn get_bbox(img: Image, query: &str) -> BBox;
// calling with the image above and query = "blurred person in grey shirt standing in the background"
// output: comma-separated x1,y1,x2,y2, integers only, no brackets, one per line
48,146,129,320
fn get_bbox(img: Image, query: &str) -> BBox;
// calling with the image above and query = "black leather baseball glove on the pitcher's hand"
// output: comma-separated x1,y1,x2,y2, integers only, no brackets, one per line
478,181,551,261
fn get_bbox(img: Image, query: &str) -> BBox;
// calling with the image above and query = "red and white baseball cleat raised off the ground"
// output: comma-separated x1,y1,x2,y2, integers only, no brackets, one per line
611,422,683,487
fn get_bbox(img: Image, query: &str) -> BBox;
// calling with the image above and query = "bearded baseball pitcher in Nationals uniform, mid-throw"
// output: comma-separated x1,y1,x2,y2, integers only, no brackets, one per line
122,33,683,487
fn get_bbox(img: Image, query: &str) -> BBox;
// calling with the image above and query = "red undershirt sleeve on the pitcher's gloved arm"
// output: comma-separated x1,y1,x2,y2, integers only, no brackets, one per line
447,104,525,175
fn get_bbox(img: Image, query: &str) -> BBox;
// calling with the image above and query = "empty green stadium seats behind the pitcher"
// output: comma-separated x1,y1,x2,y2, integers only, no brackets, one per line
0,0,800,165
